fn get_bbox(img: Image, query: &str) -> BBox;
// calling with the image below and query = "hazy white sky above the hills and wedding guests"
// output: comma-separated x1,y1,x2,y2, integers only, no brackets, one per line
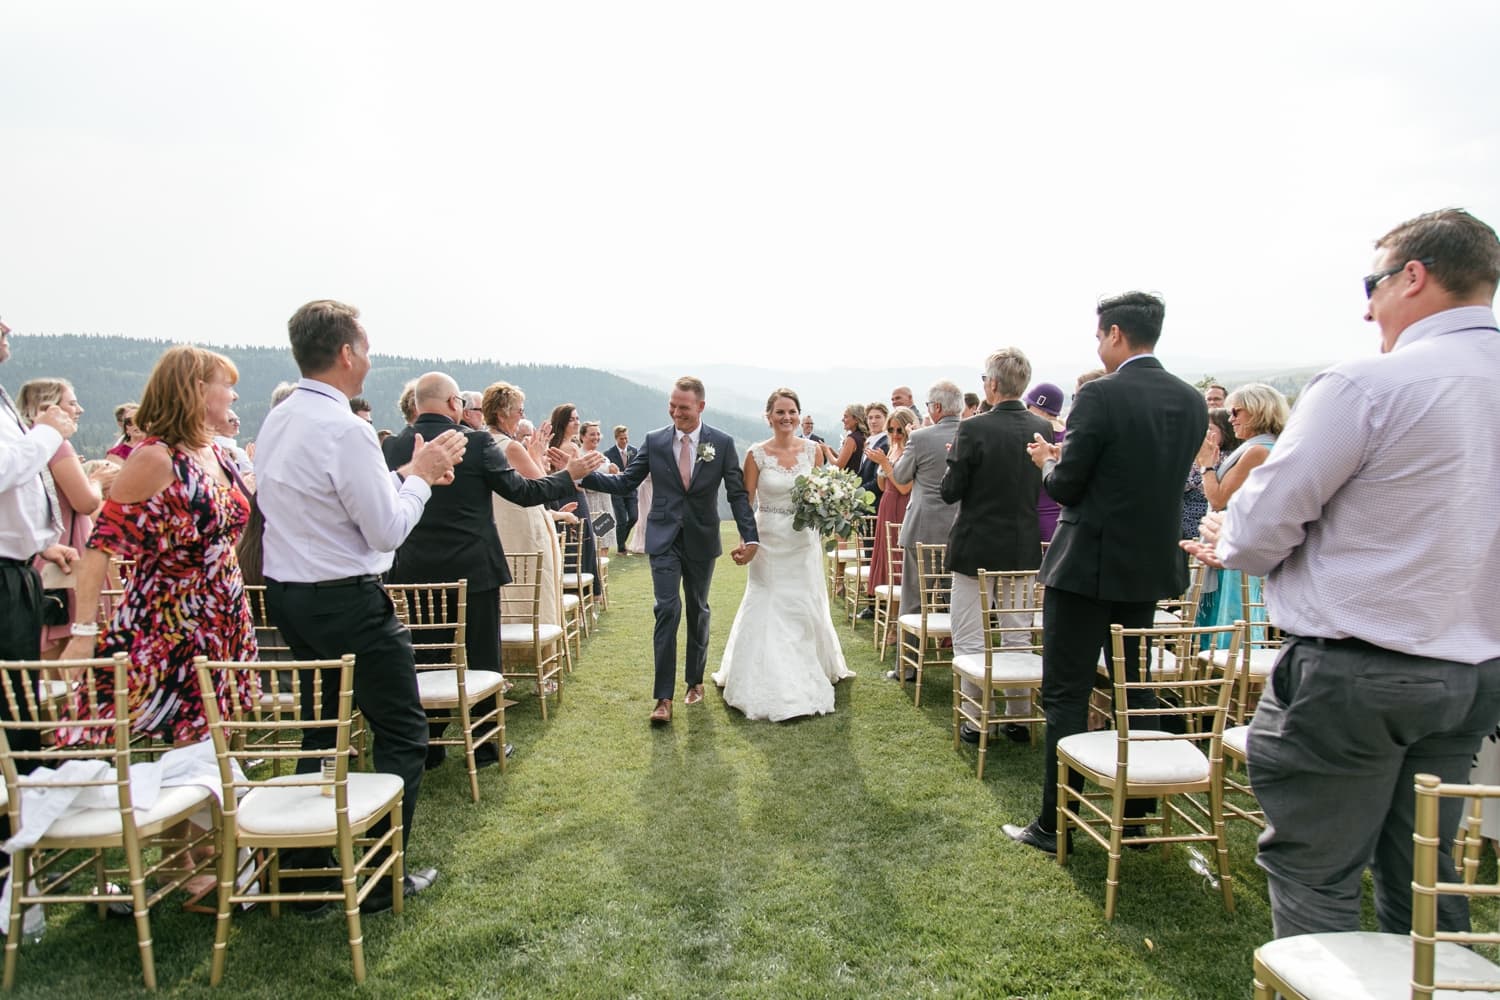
0,0,1500,379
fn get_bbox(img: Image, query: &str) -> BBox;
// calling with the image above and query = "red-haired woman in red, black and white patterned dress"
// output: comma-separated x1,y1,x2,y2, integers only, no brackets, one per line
63,346,257,744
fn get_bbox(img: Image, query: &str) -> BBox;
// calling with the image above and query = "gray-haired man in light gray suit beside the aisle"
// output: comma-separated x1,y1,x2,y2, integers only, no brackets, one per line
885,379,963,681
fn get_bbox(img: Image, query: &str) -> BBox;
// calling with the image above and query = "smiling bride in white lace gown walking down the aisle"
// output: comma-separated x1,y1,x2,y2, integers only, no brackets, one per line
714,388,854,723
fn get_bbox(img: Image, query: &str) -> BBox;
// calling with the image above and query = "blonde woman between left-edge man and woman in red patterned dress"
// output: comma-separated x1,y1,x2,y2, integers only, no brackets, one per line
17,378,120,660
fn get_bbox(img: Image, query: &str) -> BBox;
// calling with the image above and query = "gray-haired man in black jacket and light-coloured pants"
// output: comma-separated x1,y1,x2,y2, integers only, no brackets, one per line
941,348,1052,744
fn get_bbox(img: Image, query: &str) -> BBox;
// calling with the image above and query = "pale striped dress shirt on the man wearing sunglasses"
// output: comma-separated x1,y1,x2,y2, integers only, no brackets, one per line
1218,306,1500,663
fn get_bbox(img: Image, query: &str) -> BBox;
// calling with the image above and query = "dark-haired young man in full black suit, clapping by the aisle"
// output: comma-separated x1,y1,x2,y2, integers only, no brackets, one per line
1005,292,1208,852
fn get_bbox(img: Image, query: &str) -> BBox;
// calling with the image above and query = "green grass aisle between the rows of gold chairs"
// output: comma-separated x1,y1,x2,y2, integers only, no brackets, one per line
20,527,1271,1000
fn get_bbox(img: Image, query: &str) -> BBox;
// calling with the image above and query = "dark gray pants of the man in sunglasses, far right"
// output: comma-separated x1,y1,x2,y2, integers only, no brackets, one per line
1248,637,1500,937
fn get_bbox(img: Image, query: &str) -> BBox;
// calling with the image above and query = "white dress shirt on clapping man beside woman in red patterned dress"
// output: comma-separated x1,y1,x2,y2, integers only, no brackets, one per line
255,378,432,583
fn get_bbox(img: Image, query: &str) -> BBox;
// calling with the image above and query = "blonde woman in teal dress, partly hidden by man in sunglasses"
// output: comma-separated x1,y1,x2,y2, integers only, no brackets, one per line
1196,382,1292,648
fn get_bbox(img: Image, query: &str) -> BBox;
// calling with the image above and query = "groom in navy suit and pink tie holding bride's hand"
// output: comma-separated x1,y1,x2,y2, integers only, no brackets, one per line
584,376,759,723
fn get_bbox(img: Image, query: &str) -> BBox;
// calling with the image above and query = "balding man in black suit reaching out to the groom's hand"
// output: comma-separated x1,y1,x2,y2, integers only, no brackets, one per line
381,372,603,766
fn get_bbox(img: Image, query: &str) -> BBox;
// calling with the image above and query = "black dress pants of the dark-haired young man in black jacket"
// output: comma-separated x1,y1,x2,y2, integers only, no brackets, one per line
1038,586,1157,831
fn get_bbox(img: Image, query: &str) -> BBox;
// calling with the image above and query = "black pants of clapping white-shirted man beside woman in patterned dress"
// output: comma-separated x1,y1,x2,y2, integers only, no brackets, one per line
266,577,428,844
